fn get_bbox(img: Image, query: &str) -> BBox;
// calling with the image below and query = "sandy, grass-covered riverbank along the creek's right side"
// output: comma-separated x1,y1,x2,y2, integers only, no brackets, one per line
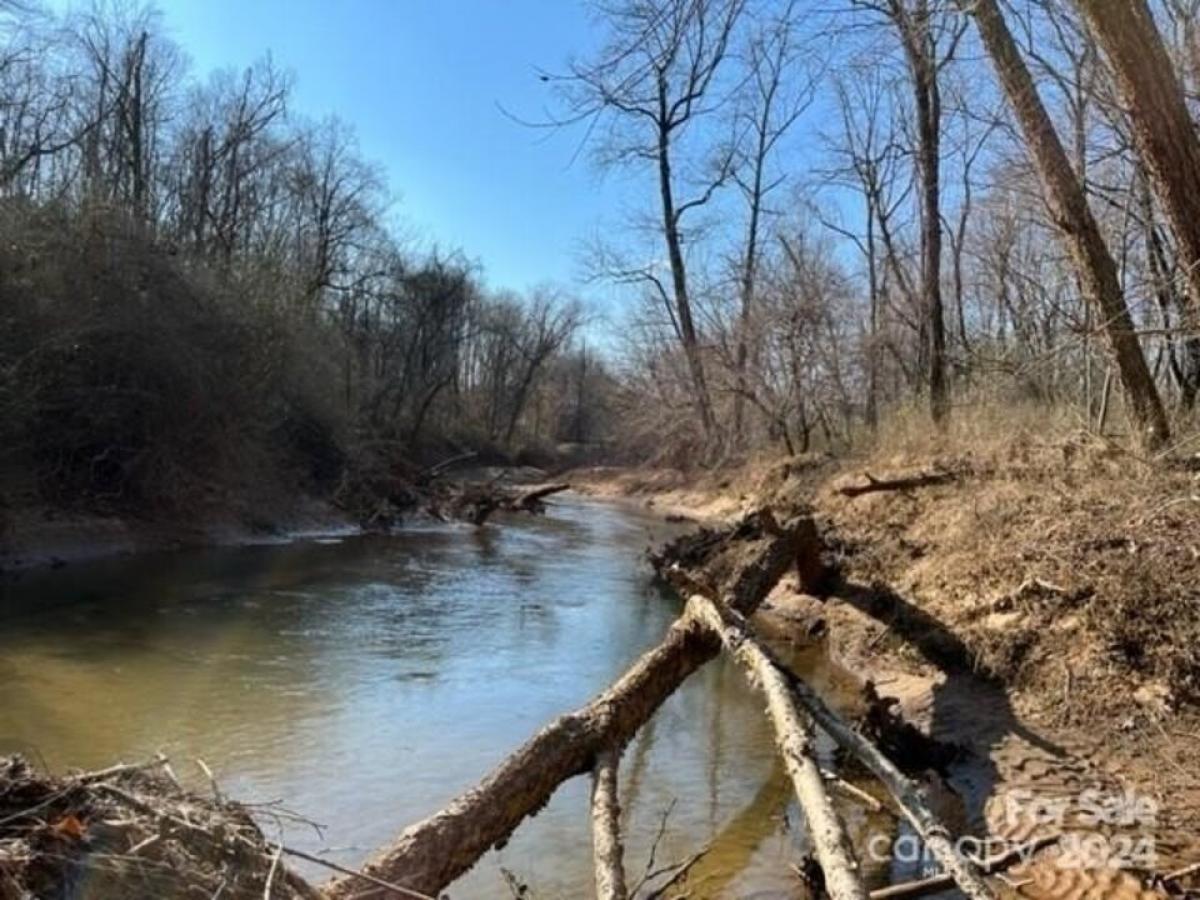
571,432,1200,894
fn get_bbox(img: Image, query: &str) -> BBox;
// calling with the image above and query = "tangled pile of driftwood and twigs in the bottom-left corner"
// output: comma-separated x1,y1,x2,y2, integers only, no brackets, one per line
0,756,320,900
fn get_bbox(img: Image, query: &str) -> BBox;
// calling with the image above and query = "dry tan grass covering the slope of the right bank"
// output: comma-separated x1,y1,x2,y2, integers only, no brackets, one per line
817,406,1200,714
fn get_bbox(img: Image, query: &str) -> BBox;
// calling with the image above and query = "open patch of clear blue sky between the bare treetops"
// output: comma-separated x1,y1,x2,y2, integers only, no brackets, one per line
157,0,629,296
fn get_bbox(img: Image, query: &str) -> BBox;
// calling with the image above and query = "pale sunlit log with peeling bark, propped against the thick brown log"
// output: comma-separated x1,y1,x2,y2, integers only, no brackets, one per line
688,594,868,900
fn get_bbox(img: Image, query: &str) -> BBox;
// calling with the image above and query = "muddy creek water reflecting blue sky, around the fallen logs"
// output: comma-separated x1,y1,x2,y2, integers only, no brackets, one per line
0,499,887,898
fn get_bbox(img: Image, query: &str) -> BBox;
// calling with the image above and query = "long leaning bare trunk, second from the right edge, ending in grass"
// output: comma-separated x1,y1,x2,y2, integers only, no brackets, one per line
960,0,1171,446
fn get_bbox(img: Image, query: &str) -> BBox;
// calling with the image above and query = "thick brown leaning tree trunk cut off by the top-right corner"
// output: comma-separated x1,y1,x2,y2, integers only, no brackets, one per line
1076,0,1200,311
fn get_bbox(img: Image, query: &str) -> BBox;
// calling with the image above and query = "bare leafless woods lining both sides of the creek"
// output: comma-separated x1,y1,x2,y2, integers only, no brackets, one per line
7,0,1200,508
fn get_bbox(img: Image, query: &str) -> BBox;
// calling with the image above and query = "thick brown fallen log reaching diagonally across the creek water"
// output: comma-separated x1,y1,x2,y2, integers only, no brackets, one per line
326,509,820,900
